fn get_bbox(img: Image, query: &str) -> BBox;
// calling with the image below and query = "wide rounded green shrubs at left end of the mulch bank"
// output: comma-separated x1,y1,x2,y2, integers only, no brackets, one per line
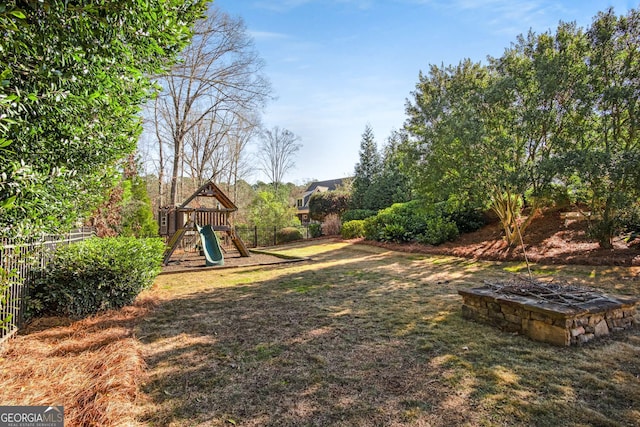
364,200,458,245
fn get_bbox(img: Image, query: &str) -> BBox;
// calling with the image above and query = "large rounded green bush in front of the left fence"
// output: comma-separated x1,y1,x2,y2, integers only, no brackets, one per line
29,237,164,317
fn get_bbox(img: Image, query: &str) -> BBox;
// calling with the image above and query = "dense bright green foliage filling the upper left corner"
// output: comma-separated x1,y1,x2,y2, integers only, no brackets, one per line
0,0,206,237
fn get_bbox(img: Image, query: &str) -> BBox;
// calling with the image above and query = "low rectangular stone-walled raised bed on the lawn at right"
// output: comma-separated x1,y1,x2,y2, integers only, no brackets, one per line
458,277,640,346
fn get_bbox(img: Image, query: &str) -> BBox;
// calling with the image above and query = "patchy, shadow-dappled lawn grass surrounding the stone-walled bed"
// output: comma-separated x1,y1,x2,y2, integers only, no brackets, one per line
136,241,640,426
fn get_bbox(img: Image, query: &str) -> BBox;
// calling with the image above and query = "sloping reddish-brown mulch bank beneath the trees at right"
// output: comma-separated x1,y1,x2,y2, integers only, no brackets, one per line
364,212,640,266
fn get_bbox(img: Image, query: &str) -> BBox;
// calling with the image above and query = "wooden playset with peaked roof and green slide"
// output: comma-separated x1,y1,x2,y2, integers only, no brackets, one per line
158,180,250,266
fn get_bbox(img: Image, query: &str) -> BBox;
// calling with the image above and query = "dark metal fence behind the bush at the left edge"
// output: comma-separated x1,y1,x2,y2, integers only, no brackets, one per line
0,227,95,343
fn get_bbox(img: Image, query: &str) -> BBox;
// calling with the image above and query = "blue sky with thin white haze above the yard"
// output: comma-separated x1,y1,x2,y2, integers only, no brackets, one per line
215,0,638,184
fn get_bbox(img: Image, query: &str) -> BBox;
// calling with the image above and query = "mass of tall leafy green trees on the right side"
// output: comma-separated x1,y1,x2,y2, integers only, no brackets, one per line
400,9,640,248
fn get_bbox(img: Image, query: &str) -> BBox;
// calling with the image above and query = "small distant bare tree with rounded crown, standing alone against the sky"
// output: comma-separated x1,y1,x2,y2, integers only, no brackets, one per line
258,126,302,190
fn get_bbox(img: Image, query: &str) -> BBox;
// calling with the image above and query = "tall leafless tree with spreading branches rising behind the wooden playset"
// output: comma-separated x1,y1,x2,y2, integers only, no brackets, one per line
155,6,271,205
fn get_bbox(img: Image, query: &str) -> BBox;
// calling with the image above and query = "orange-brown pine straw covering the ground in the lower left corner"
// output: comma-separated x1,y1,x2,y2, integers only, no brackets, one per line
0,299,155,427
